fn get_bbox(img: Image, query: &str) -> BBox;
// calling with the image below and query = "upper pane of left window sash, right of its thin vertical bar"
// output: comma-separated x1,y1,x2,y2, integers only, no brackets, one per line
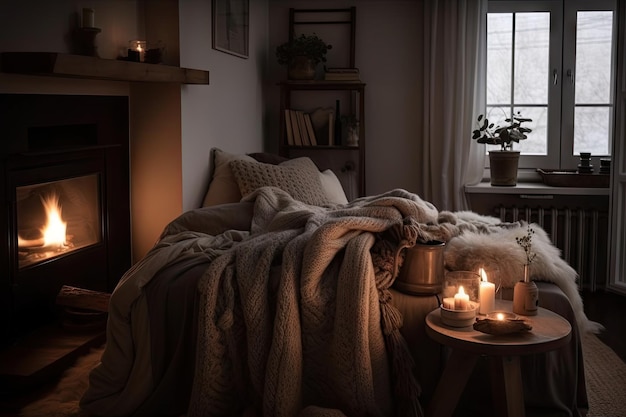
514,12,550,104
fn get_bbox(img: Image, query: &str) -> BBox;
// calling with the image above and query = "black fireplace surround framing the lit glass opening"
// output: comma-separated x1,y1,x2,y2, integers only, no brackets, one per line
0,94,131,344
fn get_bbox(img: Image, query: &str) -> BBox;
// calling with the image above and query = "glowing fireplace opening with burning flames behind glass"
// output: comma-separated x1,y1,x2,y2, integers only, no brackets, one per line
16,174,102,269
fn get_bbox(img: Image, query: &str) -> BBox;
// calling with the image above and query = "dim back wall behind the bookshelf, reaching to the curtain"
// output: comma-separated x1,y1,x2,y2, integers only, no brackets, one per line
268,0,423,194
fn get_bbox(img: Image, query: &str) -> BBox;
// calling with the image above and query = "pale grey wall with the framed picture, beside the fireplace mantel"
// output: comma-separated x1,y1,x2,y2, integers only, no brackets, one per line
180,0,268,210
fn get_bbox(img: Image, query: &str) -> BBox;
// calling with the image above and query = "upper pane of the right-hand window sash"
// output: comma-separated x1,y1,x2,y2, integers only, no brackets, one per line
575,11,613,104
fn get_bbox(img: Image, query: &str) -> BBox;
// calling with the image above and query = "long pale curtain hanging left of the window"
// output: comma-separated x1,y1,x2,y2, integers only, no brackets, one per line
421,0,487,211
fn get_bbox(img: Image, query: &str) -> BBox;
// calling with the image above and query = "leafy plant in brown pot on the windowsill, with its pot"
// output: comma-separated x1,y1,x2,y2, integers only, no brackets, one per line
472,112,532,186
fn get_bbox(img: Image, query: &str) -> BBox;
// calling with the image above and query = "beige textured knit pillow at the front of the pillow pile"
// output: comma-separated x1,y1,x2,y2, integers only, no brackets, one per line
230,157,329,206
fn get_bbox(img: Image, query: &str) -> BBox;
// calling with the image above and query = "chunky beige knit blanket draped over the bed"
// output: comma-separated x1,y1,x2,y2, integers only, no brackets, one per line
189,187,596,416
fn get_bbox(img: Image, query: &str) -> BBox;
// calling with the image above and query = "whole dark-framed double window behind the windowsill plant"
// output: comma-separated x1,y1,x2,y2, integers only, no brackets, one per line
487,0,617,169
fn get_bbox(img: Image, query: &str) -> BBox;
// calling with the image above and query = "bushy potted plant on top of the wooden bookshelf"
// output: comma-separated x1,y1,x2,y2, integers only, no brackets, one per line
276,33,332,80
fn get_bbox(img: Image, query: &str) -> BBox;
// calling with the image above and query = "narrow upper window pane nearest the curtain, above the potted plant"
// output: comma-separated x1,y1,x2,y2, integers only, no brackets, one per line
487,13,513,104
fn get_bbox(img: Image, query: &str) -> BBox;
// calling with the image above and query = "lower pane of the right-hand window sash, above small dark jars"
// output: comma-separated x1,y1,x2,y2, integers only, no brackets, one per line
573,107,611,156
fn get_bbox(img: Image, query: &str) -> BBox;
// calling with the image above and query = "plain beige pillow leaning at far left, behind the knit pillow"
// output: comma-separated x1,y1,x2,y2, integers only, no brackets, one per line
202,148,255,207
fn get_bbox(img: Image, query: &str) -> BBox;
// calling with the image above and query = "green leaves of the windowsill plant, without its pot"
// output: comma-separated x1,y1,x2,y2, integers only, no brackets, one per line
472,112,532,151
